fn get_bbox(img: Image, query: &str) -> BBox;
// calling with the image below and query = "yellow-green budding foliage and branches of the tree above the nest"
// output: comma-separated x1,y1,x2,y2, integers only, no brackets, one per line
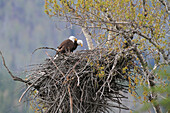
42,0,169,112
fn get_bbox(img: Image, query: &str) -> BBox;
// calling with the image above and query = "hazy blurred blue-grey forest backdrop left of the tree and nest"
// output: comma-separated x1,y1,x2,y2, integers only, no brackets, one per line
0,0,87,113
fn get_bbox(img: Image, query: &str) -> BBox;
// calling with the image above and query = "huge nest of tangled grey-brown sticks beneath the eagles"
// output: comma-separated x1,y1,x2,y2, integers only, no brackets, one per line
26,48,133,113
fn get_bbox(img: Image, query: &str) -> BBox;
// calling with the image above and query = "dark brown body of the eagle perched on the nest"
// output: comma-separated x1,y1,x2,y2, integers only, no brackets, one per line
57,39,78,53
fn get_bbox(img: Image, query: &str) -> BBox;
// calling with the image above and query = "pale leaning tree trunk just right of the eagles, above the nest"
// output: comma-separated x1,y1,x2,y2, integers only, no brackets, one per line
82,27,94,50
